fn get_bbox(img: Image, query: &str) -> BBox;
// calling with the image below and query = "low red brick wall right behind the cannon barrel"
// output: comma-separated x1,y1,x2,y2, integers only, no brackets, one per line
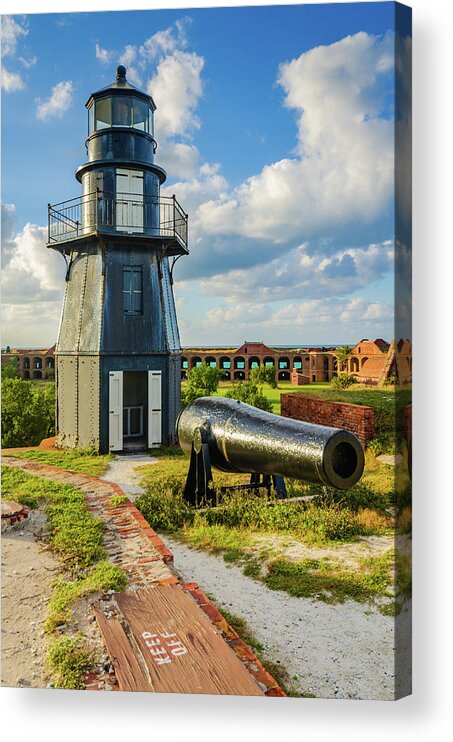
280,394,374,446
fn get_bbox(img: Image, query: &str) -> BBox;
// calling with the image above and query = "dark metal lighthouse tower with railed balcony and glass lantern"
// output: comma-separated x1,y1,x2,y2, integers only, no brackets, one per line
47,66,188,453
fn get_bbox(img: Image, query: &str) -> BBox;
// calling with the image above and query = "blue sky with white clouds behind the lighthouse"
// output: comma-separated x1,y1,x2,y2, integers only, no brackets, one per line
2,3,406,346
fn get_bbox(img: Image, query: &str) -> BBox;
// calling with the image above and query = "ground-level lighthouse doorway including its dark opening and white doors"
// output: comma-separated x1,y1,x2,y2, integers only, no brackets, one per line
109,371,162,451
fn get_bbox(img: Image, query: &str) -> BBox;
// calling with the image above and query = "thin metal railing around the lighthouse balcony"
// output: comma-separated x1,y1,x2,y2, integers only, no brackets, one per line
47,191,188,248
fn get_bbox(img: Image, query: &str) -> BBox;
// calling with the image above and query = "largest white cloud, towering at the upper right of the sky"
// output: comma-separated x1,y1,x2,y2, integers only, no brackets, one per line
197,33,394,244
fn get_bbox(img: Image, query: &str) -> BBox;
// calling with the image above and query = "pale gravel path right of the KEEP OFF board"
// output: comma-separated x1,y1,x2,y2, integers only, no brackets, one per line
163,536,394,700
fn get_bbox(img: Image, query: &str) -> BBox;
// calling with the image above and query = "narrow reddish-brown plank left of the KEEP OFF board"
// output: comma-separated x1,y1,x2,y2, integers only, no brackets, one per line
94,605,154,691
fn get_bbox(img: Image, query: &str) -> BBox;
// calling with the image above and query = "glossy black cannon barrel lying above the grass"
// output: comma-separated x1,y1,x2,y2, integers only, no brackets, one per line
176,397,364,489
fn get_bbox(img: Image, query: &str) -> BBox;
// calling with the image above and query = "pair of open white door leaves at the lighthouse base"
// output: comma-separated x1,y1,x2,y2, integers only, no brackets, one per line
109,371,162,451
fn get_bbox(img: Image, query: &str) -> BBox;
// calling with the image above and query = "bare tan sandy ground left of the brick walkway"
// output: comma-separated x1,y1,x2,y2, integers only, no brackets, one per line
1,510,60,688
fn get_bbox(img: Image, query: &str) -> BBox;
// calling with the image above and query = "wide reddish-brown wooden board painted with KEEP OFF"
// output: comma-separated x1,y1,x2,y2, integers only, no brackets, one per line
115,585,264,696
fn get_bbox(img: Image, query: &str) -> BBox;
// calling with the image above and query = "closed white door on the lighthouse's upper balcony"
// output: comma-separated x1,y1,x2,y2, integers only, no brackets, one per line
116,168,144,232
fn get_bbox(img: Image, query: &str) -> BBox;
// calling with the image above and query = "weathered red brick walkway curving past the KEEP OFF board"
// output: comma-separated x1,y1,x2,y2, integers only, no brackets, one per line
2,455,285,696
